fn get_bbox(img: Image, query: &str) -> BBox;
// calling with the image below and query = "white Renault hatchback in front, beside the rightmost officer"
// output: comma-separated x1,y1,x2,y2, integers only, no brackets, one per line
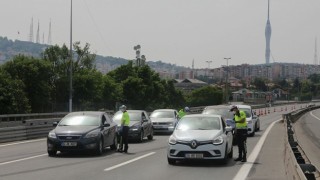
167,114,233,164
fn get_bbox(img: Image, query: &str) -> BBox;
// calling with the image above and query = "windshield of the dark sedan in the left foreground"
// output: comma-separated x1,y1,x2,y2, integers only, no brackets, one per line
59,115,101,126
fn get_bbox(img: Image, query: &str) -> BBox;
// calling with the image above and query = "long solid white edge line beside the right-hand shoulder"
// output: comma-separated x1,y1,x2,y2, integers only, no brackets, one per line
233,119,282,180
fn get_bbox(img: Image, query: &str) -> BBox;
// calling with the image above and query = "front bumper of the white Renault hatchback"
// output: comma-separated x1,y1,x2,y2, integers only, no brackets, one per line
167,143,226,159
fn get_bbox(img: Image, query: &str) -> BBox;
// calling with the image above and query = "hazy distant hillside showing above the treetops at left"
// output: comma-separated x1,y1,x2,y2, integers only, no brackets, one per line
0,36,188,73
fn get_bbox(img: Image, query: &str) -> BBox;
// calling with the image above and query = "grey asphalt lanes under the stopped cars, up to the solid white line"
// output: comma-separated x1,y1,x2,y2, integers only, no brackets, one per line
0,104,308,180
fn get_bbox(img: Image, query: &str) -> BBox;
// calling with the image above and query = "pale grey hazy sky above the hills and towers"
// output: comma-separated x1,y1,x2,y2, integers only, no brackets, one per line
0,0,320,68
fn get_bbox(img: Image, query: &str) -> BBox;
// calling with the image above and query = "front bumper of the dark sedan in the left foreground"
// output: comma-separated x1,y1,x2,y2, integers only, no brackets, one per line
47,138,100,151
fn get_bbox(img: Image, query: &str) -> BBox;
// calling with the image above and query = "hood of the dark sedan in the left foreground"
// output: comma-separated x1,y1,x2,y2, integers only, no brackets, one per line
54,126,97,134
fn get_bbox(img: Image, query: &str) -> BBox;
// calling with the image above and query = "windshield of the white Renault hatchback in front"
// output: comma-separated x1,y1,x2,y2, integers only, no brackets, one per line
176,117,220,130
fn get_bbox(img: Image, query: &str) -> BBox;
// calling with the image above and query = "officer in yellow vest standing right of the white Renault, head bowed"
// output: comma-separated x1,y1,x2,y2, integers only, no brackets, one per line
230,106,248,162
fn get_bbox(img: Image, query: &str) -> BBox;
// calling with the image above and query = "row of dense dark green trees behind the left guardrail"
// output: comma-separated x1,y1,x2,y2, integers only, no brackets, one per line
0,42,223,114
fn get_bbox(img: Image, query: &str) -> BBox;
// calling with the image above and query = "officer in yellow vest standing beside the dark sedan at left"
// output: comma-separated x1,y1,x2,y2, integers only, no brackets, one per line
118,105,130,153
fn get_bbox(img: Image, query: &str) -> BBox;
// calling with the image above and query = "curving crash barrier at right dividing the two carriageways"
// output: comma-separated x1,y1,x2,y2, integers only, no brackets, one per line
283,107,320,180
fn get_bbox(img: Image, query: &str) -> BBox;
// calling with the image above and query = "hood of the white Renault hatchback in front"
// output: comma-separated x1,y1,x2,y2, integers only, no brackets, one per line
173,130,221,141
